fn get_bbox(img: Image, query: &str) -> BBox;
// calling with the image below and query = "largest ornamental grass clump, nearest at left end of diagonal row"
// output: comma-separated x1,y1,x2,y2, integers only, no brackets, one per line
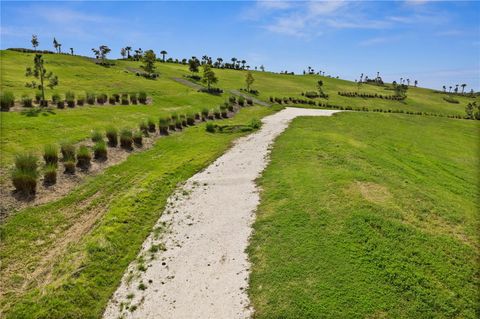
12,154,38,196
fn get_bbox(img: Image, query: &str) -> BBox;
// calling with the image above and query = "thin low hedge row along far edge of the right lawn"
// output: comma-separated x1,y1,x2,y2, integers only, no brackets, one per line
270,97,470,119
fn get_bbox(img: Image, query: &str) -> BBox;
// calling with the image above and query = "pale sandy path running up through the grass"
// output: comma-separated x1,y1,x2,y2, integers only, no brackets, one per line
104,108,337,319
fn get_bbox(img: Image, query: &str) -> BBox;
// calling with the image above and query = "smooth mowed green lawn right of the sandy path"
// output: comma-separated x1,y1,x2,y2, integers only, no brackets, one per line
249,113,480,318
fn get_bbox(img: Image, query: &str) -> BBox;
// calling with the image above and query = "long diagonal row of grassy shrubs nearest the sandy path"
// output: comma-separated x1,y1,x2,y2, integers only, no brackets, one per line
12,96,251,196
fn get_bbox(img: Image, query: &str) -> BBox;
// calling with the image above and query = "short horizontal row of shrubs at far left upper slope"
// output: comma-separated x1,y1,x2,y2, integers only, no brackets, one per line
0,91,148,111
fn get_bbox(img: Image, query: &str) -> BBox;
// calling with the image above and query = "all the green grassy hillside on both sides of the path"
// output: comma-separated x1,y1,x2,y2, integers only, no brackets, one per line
0,51,480,318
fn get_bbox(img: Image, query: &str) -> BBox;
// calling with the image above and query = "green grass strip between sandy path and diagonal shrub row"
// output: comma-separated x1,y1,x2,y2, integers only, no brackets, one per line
0,107,280,318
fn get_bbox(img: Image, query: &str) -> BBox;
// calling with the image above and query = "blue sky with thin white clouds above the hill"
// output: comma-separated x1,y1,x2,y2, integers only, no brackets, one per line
0,0,480,90
